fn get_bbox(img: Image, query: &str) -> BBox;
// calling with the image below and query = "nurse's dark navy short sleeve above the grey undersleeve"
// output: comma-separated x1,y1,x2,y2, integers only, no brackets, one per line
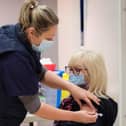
0,52,39,96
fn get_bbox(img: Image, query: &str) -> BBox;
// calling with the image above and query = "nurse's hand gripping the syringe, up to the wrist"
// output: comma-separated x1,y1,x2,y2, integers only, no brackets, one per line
74,110,98,123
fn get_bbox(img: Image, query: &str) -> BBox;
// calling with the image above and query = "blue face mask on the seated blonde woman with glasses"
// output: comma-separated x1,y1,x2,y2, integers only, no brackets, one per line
69,74,86,85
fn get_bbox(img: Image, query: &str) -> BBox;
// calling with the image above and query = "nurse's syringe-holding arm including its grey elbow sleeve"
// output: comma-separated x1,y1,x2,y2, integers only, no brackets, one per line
19,95,97,123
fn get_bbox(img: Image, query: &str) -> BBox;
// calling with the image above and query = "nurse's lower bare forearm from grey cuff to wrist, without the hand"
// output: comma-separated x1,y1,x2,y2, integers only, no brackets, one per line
34,103,76,121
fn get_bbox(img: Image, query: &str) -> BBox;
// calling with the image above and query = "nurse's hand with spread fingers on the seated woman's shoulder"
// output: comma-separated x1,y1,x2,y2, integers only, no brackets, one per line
69,85,100,111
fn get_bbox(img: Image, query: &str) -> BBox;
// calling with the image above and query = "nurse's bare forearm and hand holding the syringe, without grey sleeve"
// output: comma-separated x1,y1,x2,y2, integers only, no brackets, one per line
34,103,97,123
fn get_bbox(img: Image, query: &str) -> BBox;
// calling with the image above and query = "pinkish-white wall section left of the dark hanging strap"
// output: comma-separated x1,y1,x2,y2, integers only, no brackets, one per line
58,0,80,69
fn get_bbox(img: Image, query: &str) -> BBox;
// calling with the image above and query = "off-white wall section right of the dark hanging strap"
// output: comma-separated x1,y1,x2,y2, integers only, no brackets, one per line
85,0,121,126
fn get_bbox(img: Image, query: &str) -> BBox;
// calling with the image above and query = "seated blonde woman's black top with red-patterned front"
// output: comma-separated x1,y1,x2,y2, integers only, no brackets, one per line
54,96,118,126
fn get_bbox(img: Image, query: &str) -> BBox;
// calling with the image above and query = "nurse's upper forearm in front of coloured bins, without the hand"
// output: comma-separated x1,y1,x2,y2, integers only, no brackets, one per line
42,71,74,91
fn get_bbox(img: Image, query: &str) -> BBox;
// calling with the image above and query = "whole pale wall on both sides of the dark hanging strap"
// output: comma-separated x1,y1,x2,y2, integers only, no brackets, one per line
58,0,121,126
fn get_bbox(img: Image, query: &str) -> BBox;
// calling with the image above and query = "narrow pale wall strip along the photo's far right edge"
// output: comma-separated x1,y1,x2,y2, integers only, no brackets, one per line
120,0,126,126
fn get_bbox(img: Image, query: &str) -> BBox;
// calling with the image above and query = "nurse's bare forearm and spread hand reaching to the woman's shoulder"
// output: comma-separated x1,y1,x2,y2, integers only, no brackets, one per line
42,71,99,109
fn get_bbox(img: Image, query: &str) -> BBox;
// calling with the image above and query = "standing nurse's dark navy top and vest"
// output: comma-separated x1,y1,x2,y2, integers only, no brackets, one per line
0,24,45,126
